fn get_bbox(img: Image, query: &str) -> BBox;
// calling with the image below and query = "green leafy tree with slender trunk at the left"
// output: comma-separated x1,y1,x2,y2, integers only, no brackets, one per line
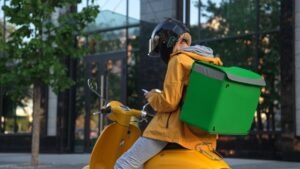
0,0,99,166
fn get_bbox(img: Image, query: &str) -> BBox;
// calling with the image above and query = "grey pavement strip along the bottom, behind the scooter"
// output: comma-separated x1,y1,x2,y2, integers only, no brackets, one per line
0,153,300,169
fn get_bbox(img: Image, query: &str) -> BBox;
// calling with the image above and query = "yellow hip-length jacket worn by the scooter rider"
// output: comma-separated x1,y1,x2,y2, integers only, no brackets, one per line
143,48,222,150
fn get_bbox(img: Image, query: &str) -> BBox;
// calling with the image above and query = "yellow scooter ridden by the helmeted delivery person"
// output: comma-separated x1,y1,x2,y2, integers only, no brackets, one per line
83,80,230,169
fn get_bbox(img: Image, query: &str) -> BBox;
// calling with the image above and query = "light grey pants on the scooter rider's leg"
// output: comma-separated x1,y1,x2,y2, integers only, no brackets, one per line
115,137,168,169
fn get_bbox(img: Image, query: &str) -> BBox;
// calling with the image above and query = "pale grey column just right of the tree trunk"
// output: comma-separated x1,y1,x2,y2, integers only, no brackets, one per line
47,88,57,136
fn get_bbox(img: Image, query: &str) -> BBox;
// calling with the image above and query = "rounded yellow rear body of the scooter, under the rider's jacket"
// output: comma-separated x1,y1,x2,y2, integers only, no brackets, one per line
144,149,230,169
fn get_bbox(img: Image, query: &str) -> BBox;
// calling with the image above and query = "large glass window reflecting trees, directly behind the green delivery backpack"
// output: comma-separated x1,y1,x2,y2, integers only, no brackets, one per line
190,0,281,131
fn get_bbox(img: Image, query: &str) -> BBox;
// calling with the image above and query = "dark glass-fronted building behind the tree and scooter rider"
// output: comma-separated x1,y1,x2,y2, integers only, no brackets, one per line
0,0,300,161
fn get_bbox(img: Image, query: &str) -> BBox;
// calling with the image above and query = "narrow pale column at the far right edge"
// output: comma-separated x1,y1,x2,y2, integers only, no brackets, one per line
295,0,300,136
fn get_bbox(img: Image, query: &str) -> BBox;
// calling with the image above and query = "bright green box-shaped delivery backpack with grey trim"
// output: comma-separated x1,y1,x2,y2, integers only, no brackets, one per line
180,61,265,135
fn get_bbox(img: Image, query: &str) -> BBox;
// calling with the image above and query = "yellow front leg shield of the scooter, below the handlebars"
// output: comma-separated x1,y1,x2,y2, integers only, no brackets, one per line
89,123,141,169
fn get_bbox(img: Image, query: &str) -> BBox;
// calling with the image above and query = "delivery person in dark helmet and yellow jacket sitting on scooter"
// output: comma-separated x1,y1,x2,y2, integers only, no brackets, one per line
115,18,222,169
